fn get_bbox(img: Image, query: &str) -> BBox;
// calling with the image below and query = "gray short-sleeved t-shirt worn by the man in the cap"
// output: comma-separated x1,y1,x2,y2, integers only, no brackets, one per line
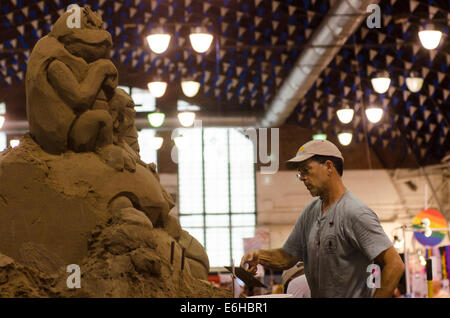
283,190,392,298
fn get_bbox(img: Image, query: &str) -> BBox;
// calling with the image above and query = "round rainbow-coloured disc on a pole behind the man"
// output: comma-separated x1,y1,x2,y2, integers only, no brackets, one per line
413,209,447,246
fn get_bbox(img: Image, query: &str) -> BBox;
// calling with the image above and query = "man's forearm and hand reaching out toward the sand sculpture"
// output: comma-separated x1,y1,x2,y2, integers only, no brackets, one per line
241,248,299,274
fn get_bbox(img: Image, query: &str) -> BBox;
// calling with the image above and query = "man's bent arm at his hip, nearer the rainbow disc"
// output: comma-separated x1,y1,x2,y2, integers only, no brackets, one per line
374,246,405,298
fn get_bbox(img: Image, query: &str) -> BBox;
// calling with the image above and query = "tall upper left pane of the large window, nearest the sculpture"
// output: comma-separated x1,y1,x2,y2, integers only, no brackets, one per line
178,128,203,213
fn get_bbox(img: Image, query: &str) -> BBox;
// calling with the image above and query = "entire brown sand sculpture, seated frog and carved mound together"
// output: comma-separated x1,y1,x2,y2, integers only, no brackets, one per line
0,7,228,297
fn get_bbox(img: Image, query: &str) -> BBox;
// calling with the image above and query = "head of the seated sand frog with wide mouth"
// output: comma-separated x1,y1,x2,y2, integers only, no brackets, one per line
50,7,112,63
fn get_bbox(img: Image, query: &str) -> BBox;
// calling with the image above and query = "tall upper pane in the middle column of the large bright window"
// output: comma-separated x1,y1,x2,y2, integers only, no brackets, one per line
203,128,229,213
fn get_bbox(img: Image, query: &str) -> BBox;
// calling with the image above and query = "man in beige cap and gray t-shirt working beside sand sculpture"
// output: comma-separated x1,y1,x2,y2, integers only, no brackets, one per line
241,140,404,297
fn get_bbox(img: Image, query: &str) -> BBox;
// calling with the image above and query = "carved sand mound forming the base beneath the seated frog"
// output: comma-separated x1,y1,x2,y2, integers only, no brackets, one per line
0,135,229,297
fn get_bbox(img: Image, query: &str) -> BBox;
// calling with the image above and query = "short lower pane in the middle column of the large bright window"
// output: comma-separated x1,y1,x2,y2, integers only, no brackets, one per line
206,228,230,267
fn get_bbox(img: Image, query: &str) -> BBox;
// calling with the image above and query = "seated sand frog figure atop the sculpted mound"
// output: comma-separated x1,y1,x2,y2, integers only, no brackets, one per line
26,7,136,171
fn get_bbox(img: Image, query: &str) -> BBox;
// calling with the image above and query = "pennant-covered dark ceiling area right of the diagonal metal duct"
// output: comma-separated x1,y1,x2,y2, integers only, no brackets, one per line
293,0,450,164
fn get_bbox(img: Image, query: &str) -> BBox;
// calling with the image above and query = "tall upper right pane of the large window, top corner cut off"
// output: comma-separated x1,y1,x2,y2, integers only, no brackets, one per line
230,129,255,213
